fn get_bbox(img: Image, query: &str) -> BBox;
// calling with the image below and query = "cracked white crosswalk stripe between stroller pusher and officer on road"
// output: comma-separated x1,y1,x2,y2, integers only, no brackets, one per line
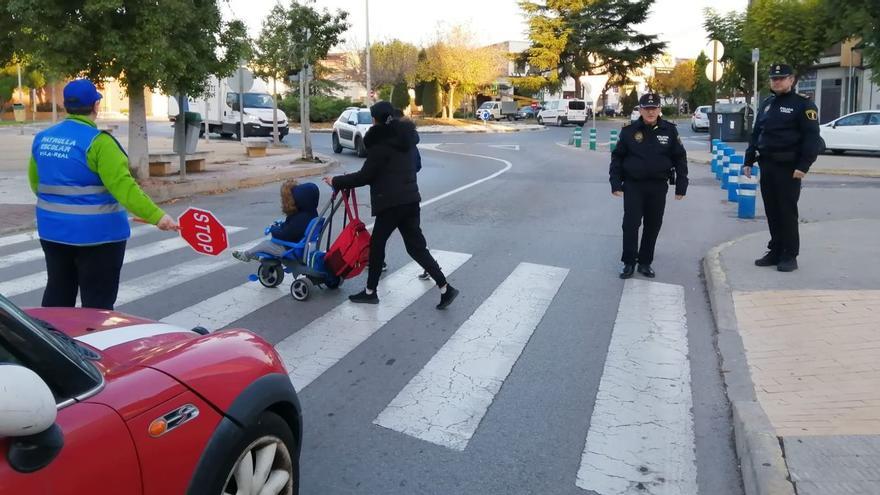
373,263,568,450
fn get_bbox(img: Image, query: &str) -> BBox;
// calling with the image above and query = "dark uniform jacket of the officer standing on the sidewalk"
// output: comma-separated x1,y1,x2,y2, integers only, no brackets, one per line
745,91,821,172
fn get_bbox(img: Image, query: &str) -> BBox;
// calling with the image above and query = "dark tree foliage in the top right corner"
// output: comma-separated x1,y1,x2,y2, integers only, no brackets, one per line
821,0,880,84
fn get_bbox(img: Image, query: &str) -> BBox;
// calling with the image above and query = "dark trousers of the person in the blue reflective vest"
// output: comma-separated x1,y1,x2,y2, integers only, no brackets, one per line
40,240,126,309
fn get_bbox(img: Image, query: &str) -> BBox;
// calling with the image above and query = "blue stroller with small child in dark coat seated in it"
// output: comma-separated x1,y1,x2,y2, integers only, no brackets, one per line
232,179,341,301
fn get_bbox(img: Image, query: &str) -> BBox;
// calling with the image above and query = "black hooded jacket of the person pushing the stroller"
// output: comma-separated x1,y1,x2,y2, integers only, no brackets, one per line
333,120,422,216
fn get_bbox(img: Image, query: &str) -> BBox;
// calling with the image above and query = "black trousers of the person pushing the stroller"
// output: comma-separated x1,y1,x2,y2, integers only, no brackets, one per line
367,203,446,290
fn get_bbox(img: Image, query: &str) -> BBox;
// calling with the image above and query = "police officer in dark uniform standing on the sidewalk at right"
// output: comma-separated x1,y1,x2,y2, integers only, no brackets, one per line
743,64,820,272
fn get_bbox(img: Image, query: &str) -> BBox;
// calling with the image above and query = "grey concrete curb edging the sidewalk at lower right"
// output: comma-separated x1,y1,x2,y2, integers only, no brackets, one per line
703,236,796,495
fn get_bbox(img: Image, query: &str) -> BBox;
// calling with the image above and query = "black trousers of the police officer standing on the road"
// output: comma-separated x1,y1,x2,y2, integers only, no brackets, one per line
620,180,669,265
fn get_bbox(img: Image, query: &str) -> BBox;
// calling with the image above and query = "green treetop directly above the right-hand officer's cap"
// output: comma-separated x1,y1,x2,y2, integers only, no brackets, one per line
743,0,833,74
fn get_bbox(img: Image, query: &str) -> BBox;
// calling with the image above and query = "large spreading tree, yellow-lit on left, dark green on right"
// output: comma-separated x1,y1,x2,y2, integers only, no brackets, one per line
519,0,666,98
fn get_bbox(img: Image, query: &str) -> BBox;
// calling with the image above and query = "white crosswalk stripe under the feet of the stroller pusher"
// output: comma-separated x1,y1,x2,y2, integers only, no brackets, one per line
275,250,471,390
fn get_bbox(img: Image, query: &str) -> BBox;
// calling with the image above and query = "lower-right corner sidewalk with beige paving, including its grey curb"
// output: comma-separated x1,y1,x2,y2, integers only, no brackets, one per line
703,219,880,495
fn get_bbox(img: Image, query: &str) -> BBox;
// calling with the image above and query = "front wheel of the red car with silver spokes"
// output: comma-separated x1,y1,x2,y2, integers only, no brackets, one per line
219,411,299,495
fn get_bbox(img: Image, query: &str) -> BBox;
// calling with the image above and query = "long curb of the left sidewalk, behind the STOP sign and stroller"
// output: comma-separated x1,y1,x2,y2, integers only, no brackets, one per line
141,155,339,203
